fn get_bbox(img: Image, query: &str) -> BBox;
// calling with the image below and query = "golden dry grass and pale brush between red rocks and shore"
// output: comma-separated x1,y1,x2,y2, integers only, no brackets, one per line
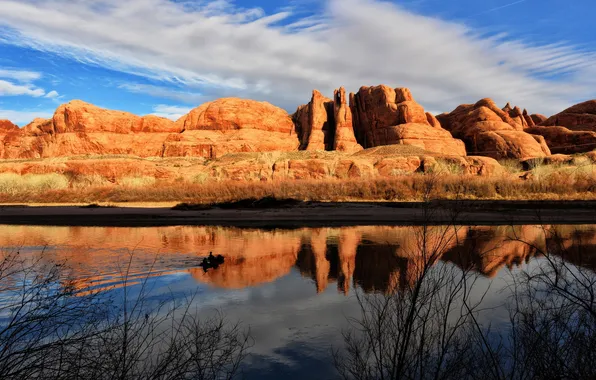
0,157,596,204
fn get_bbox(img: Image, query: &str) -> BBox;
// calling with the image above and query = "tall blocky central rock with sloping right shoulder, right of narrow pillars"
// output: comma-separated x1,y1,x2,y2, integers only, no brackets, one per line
350,85,466,156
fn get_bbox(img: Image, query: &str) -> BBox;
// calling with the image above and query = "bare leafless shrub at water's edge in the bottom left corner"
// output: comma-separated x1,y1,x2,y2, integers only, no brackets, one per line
0,252,250,379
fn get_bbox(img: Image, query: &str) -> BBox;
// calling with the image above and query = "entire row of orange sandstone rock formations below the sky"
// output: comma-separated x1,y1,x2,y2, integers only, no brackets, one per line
0,85,596,163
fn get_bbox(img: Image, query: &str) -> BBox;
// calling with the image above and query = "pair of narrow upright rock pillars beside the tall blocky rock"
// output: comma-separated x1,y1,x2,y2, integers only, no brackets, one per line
293,87,362,152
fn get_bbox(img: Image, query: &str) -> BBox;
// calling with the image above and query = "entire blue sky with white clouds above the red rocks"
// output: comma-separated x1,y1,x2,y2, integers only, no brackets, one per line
0,0,596,125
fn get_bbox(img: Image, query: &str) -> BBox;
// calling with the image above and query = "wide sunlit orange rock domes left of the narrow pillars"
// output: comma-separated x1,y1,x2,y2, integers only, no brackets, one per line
0,99,297,159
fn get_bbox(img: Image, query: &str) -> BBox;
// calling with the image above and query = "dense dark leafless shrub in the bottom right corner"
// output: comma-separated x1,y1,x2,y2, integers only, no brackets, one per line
472,224,596,379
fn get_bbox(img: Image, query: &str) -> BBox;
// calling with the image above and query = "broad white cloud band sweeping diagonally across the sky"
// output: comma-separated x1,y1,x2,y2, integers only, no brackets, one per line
0,0,596,114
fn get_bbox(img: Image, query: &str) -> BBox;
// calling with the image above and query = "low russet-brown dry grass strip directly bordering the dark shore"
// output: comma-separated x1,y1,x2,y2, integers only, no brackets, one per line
0,168,596,204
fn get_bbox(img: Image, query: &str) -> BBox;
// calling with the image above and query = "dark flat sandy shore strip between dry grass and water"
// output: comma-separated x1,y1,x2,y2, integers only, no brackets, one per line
0,201,596,228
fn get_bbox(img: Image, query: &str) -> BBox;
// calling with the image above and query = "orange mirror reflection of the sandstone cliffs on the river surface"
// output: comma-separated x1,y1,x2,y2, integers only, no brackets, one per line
0,225,596,294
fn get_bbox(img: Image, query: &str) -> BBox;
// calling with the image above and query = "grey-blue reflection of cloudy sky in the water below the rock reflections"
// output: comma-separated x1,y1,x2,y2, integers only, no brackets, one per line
106,264,510,379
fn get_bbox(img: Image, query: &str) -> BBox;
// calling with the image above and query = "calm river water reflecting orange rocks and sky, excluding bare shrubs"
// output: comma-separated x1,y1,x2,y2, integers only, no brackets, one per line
0,225,596,379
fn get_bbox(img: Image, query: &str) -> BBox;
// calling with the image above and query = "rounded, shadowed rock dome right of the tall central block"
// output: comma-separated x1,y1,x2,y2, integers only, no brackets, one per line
437,99,550,159
